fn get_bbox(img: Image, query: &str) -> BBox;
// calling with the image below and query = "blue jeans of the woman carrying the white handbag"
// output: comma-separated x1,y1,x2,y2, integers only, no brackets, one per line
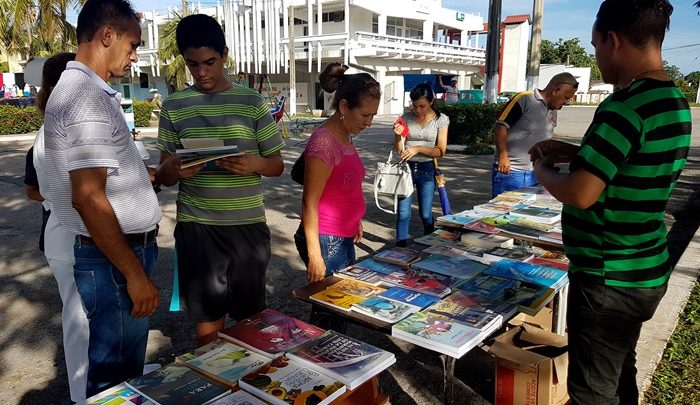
396,160,435,241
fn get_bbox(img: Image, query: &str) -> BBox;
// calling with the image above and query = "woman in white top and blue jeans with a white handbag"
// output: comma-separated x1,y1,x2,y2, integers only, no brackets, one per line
394,83,450,246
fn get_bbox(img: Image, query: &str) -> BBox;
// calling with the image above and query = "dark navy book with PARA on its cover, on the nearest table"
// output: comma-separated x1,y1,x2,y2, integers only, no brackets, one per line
126,364,230,405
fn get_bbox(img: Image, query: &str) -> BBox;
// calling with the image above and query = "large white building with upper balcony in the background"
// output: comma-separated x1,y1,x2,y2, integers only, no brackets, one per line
223,0,485,114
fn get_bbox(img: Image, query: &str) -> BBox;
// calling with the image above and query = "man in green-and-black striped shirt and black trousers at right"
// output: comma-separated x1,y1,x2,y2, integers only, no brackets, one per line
530,0,691,405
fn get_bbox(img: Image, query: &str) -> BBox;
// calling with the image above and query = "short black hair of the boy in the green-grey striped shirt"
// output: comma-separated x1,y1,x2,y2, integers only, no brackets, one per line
175,14,226,57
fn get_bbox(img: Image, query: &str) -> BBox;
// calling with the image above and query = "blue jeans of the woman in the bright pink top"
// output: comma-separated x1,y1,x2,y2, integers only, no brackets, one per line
294,226,355,277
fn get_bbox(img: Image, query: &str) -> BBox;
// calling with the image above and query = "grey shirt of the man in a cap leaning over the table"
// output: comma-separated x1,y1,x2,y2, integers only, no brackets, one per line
493,89,557,172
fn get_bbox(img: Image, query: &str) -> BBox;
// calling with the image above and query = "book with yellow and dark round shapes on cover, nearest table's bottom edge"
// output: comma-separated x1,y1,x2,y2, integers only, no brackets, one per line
239,356,346,405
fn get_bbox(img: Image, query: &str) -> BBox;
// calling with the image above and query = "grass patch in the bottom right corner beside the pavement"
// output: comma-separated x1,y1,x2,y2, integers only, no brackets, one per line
645,283,700,405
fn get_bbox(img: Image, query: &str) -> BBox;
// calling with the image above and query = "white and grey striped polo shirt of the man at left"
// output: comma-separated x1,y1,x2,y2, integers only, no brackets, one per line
44,61,162,236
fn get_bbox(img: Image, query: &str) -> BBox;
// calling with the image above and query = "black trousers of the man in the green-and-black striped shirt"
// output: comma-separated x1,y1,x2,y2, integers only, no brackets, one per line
566,274,666,405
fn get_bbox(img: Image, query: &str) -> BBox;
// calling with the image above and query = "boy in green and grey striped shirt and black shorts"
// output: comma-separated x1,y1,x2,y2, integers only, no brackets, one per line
156,14,285,345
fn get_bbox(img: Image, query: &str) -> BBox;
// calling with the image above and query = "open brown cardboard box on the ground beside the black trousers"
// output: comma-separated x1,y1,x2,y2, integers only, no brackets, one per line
489,323,569,405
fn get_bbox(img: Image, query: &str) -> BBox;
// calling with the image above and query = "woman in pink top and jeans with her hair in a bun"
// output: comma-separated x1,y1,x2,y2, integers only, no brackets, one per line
294,63,380,282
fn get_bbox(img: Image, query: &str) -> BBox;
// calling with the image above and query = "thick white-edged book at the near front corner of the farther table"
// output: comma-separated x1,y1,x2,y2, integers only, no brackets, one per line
391,312,483,358
